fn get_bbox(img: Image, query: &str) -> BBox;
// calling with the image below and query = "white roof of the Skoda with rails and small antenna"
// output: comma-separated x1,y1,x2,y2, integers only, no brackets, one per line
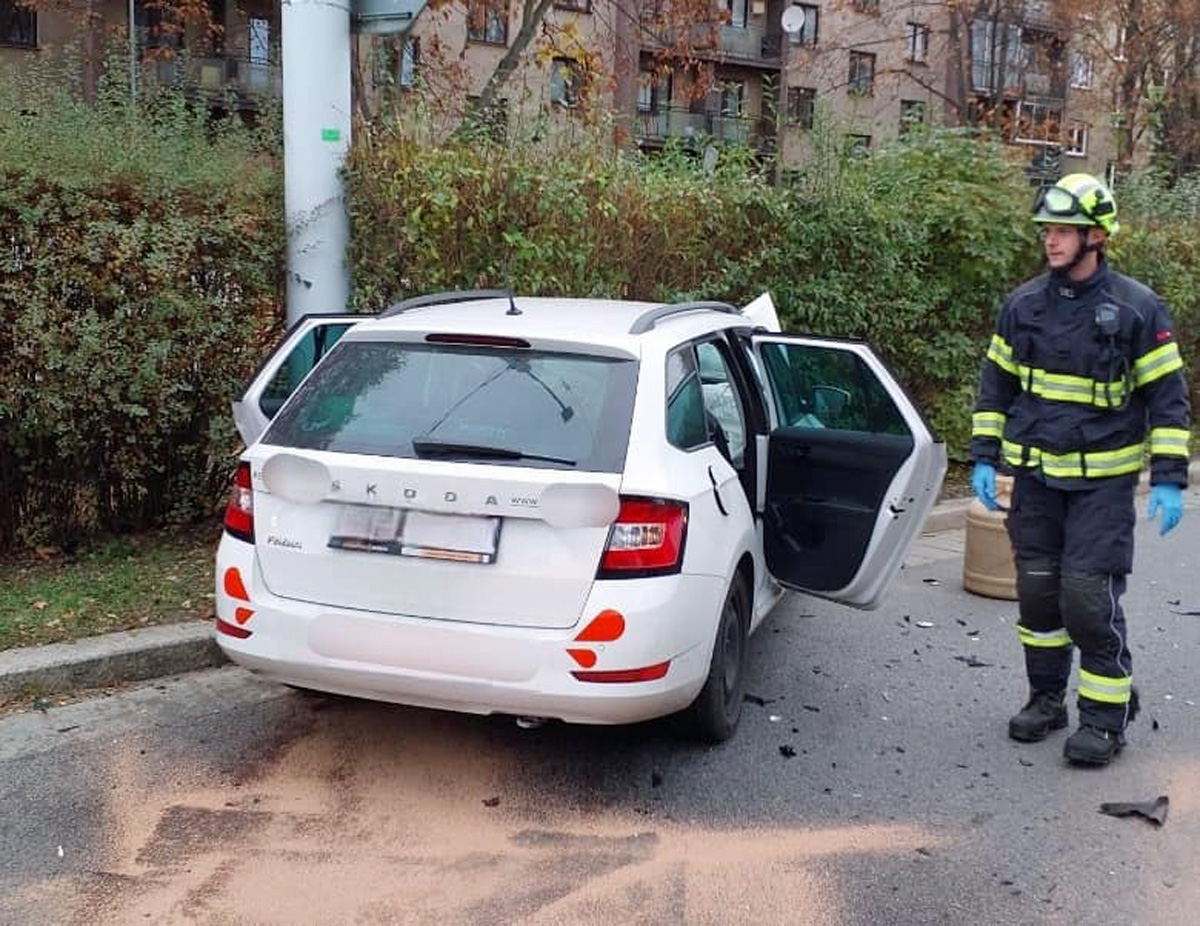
347,296,750,355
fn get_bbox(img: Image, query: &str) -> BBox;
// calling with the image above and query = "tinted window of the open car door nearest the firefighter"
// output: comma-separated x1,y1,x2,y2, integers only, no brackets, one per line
762,343,908,435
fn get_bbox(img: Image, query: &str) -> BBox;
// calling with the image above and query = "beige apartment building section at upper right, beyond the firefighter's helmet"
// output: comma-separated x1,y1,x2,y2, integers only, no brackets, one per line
781,0,1116,182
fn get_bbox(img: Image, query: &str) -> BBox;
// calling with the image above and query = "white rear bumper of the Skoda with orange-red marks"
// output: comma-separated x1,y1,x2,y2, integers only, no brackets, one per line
216,536,725,723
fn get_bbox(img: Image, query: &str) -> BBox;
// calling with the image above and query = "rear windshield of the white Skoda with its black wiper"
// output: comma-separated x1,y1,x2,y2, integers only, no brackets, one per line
263,341,637,473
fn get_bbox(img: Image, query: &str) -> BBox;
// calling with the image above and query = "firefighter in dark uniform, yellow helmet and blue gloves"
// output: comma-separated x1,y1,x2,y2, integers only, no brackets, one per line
971,174,1190,765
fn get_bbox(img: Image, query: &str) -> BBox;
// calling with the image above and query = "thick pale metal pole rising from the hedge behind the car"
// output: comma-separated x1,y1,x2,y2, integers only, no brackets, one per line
281,0,350,325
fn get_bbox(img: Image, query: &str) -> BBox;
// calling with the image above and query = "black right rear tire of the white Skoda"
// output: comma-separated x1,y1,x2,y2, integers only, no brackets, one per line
680,576,750,742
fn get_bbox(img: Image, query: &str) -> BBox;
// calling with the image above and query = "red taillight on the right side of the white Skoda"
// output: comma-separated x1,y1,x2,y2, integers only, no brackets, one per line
596,497,688,578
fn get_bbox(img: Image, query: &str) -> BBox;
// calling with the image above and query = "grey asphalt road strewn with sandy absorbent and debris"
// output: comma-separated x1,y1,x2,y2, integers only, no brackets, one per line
0,494,1200,926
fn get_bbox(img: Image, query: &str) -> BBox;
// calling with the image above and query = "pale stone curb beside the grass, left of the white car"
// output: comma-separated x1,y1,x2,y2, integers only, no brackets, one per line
0,620,227,703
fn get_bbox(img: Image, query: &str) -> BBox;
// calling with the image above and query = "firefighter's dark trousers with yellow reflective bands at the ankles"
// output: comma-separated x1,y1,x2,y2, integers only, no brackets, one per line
1008,474,1136,730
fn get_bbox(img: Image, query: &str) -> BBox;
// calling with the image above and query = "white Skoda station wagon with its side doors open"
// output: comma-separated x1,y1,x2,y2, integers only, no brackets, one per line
216,291,946,741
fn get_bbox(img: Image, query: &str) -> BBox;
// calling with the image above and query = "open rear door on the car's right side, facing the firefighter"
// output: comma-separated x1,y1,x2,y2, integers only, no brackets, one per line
752,333,946,608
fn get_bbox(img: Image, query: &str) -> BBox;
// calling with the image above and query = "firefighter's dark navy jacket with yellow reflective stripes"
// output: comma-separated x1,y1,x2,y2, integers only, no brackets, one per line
971,258,1190,489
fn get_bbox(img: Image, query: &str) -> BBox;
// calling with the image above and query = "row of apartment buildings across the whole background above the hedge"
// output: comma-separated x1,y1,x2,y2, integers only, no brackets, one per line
0,0,1142,182
